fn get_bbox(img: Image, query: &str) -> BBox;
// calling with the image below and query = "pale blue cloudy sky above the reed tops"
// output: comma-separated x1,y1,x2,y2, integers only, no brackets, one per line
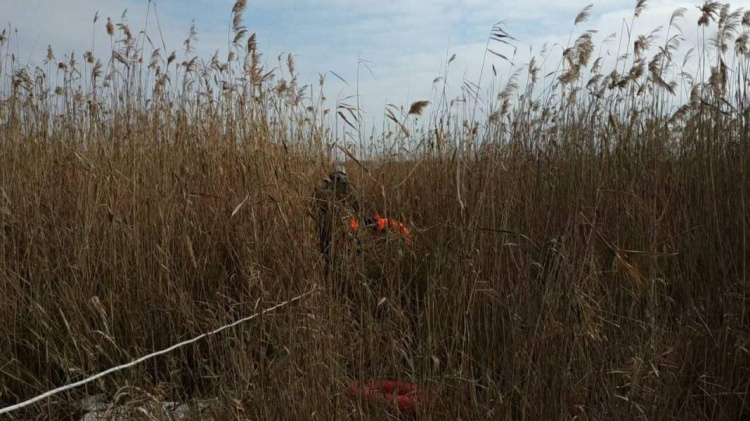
0,0,750,130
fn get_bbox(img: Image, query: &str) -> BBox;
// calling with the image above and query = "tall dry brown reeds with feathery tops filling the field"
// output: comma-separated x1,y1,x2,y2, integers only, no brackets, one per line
0,0,750,420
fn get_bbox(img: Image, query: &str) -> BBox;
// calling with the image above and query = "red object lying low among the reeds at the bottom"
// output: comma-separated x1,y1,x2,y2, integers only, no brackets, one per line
346,380,432,412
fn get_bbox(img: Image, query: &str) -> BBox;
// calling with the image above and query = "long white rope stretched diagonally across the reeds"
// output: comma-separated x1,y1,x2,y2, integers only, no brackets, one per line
0,289,315,414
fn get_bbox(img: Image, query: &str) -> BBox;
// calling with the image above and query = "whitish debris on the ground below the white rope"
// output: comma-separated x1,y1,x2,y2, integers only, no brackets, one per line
80,395,217,421
